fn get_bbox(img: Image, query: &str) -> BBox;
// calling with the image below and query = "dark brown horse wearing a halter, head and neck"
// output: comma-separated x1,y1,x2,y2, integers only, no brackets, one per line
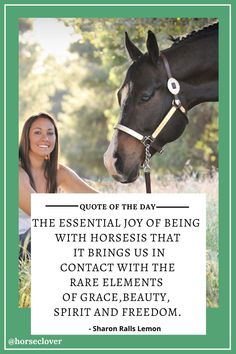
104,23,218,183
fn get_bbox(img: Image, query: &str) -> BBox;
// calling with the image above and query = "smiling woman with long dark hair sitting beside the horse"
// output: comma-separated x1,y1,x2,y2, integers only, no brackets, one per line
19,113,96,257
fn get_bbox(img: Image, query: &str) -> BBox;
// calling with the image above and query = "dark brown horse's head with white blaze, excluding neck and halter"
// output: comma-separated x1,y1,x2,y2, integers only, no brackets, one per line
104,31,187,183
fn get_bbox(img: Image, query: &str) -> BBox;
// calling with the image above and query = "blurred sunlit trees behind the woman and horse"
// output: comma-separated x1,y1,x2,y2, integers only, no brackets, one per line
19,18,218,181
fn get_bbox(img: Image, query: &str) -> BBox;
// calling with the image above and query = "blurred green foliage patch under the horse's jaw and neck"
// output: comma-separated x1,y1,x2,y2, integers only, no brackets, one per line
153,103,218,175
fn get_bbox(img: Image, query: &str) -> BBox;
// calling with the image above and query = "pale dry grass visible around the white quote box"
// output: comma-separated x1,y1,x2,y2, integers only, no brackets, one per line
19,173,219,307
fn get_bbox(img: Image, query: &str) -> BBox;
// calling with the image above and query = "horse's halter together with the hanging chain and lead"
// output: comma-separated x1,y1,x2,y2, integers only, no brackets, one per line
114,53,188,193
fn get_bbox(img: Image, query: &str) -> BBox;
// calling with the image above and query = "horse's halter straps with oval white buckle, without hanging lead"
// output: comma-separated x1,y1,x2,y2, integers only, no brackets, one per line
114,53,187,152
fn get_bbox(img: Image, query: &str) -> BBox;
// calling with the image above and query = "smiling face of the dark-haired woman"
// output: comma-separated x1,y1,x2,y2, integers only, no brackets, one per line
29,118,56,158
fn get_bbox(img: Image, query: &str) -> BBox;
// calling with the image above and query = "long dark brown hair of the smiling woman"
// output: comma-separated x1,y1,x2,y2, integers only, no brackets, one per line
19,113,59,193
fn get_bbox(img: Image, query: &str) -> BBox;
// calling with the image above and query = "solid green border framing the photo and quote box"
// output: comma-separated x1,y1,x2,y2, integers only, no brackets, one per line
1,0,233,353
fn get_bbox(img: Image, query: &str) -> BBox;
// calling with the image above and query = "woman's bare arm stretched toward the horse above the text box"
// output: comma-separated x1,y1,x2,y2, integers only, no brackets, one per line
57,165,98,193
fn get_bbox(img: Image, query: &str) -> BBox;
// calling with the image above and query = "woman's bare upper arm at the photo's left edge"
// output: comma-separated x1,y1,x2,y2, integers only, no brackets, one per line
19,167,35,215
